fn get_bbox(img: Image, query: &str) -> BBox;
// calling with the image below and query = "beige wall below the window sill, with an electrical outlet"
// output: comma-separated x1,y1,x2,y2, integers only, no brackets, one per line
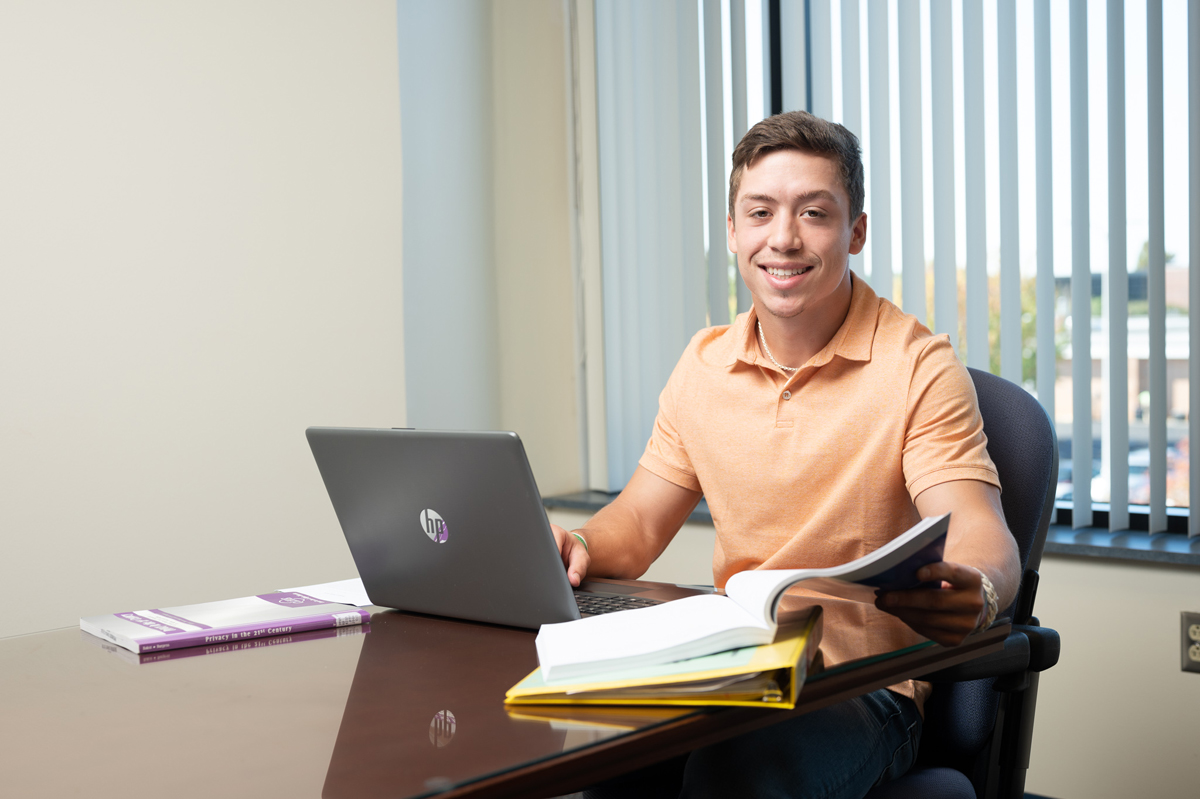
1026,555,1200,799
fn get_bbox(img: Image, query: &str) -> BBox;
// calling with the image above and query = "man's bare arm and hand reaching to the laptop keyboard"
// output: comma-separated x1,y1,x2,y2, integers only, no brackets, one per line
551,467,702,587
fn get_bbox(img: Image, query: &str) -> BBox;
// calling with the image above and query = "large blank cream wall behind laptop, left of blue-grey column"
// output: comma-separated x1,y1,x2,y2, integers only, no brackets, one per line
0,0,404,636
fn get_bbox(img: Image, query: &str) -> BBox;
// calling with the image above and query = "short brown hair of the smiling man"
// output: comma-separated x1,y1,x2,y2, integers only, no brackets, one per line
730,112,866,224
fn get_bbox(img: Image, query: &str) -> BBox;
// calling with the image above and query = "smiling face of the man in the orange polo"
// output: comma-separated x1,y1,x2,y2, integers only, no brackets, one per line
727,150,866,319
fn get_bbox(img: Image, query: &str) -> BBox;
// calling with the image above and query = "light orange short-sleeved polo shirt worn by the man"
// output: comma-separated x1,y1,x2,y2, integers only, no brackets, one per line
640,275,1000,704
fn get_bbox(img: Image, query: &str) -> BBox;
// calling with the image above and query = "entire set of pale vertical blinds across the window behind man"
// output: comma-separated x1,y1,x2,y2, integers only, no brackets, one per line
595,0,1200,535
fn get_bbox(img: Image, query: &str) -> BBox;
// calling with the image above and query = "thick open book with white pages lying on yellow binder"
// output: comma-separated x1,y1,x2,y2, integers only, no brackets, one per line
536,513,950,684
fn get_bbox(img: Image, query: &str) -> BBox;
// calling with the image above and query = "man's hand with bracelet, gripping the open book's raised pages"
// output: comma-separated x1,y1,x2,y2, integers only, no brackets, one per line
875,561,986,647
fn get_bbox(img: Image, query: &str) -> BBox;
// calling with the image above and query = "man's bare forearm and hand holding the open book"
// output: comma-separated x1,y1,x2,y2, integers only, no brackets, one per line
876,480,1021,645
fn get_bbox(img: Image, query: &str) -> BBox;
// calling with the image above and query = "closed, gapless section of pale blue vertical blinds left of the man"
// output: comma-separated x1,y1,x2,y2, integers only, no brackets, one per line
595,0,705,488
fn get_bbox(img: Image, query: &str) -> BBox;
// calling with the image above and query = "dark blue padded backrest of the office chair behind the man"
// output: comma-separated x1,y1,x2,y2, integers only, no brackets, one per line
918,370,1058,795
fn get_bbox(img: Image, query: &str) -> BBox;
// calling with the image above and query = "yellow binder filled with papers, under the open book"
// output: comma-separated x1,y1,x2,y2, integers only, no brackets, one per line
504,607,821,709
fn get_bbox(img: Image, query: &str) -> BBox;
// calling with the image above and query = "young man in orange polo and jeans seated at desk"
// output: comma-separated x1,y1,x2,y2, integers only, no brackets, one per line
554,112,1020,797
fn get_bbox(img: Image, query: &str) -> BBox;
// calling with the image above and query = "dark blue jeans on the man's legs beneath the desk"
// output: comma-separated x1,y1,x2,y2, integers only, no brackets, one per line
584,689,922,799
